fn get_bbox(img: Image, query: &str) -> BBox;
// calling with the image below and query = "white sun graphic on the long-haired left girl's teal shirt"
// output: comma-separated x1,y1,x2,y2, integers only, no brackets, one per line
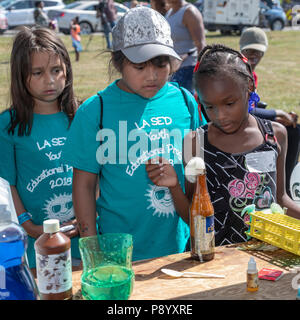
43,193,74,222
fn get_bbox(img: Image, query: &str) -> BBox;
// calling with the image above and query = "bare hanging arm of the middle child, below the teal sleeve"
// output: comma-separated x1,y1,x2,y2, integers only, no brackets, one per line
73,168,98,237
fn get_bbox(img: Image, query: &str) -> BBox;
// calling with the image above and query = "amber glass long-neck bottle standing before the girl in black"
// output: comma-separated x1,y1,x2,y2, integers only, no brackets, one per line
190,170,215,262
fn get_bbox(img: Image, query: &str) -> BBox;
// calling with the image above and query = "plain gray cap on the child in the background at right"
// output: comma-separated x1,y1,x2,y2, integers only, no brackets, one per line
240,27,268,52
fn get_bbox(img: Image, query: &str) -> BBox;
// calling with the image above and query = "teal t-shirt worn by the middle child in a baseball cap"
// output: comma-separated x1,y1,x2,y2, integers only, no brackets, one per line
63,81,206,260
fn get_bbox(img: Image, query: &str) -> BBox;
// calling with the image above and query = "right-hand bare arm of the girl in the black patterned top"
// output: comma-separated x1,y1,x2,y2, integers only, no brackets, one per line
272,122,300,219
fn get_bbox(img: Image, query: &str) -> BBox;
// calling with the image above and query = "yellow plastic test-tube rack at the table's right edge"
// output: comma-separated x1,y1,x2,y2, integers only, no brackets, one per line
246,211,300,255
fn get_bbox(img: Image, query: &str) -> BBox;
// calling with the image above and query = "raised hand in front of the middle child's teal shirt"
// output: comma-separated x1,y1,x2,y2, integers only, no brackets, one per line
146,157,178,188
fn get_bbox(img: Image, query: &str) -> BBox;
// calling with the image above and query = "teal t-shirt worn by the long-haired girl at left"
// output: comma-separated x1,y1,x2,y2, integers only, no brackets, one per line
0,111,80,268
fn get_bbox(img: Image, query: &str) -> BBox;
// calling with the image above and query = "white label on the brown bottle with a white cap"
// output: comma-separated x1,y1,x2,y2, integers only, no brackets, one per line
36,249,72,294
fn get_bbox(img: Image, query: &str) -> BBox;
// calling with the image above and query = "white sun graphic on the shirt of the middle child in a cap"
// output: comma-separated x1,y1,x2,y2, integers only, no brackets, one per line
145,185,175,217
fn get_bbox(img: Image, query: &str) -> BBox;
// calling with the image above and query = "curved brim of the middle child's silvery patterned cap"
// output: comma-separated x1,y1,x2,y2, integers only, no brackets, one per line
121,43,182,63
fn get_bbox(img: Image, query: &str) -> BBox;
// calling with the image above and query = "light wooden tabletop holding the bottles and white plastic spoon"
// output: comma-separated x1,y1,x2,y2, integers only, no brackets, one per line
73,245,300,300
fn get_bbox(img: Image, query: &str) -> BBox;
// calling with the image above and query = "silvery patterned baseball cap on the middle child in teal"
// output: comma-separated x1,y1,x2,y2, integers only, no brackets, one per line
112,6,181,63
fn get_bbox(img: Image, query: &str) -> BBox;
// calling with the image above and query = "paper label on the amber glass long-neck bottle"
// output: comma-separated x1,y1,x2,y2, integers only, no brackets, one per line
194,216,214,256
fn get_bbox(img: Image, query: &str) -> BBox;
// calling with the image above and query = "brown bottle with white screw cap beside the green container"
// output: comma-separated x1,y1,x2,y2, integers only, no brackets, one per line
34,219,72,300
